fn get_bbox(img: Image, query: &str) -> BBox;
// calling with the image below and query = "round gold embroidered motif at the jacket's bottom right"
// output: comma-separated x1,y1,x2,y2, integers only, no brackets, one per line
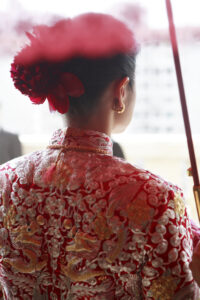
150,275,177,300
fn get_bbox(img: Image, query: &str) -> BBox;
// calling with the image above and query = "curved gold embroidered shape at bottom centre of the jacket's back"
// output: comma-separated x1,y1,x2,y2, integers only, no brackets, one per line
61,258,105,281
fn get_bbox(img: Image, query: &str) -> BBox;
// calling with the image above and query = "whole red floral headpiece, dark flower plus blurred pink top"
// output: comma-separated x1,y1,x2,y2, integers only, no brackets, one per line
11,13,138,113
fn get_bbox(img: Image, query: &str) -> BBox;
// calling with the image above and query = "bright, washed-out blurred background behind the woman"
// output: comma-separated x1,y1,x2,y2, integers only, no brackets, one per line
0,0,200,220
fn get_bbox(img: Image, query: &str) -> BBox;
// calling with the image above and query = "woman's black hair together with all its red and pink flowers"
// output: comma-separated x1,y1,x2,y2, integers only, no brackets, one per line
11,13,137,116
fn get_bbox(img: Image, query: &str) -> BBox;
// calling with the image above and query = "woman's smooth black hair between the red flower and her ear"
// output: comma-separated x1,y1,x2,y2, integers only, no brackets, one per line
63,54,136,116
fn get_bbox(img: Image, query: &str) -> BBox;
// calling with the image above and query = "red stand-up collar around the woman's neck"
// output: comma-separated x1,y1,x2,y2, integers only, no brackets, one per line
50,127,113,155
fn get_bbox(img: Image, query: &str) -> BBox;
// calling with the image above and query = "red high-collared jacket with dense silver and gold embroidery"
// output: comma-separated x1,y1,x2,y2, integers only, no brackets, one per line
0,128,198,300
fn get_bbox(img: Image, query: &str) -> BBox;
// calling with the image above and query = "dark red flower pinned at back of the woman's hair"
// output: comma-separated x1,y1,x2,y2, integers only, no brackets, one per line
11,63,84,114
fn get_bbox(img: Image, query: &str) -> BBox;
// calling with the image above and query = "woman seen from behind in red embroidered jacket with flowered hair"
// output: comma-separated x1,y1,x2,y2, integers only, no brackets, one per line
0,13,197,300
